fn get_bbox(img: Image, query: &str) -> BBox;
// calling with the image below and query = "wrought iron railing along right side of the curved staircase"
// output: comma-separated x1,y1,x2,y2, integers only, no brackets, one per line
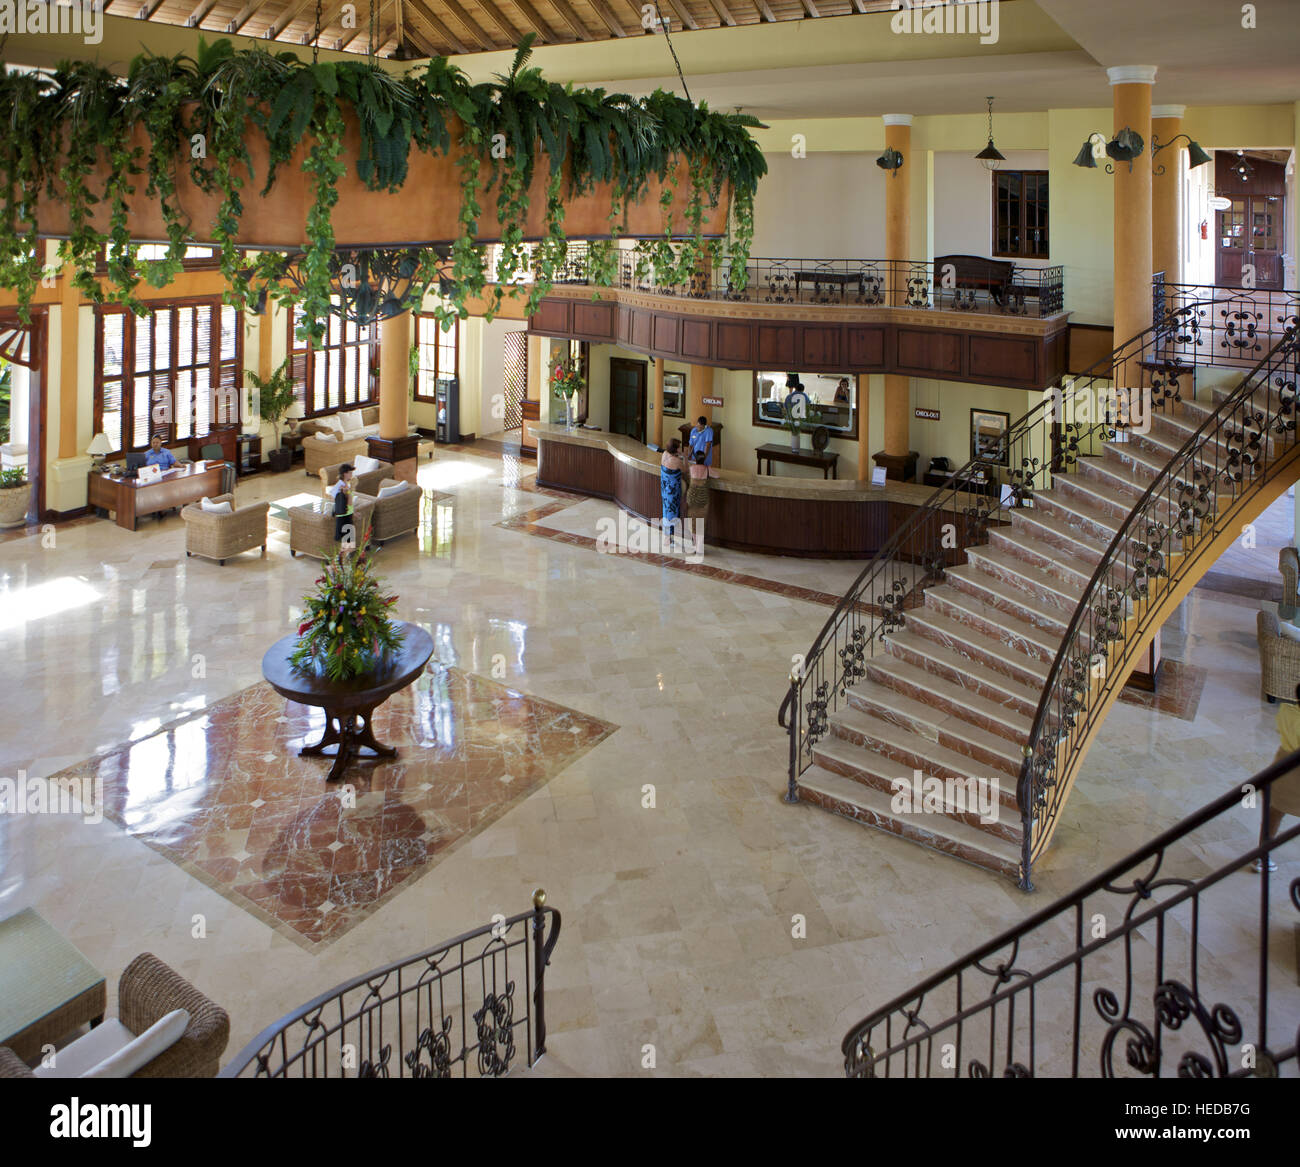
1017,327,1300,888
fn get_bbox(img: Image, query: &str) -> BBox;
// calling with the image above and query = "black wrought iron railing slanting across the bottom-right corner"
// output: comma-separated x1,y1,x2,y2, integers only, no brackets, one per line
841,754,1300,1077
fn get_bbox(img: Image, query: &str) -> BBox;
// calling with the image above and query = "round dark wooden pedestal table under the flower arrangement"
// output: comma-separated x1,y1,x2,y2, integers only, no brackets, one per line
261,621,433,782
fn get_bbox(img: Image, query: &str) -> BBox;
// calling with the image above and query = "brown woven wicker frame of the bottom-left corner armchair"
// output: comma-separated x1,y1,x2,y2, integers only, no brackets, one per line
0,953,230,1077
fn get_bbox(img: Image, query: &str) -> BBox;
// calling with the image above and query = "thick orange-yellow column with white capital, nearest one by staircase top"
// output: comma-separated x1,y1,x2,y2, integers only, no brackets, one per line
1106,65,1156,376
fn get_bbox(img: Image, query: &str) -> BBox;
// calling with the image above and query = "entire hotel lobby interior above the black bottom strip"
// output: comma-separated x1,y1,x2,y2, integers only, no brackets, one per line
0,0,1300,1096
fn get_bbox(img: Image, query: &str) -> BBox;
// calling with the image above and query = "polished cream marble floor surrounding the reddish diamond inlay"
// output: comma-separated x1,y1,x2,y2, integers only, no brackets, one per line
0,451,1300,1076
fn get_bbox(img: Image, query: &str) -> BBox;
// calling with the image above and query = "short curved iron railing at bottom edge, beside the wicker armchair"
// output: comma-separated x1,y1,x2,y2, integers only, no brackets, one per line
221,890,560,1077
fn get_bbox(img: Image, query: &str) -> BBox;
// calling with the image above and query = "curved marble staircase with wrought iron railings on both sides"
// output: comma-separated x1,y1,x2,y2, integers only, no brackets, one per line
781,297,1300,889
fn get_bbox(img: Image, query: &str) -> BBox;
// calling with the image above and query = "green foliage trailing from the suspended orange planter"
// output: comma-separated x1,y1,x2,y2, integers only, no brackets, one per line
0,35,767,344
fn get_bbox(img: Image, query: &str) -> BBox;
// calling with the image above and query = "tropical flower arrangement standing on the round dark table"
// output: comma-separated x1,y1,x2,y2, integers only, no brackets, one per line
289,529,402,681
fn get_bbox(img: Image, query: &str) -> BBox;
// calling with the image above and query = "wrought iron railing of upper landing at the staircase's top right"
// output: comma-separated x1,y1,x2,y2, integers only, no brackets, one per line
1152,272,1300,368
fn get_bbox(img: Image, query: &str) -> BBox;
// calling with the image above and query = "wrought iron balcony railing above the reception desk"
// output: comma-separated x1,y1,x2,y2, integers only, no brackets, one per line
485,242,1065,317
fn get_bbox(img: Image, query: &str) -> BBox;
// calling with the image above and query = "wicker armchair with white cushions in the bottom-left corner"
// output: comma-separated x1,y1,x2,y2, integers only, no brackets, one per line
0,953,230,1077
